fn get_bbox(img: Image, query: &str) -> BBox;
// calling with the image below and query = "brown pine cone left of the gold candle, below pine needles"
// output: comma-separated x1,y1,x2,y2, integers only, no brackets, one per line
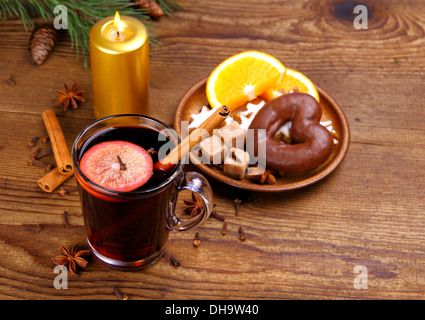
29,24,57,65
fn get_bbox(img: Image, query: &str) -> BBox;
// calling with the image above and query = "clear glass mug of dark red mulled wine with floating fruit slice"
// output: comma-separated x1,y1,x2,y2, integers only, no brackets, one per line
72,115,213,269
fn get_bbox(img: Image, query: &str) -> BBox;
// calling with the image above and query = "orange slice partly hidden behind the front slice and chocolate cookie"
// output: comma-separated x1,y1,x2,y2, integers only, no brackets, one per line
261,68,319,101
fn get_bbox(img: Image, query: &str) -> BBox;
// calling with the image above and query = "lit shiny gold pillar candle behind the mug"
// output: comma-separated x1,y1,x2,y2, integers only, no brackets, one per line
90,12,149,119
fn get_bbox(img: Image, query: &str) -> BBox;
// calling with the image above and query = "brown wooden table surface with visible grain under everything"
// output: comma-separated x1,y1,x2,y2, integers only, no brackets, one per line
0,0,425,299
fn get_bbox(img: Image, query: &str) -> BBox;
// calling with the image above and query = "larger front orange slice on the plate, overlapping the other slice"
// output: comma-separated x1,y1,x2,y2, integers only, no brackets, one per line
206,51,286,110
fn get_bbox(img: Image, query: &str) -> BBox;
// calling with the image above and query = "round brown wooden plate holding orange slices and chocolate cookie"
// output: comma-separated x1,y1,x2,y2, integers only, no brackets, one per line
174,79,350,192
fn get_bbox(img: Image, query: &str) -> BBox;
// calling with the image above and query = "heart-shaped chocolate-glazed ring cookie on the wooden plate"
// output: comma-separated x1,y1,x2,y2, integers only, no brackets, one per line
249,93,333,173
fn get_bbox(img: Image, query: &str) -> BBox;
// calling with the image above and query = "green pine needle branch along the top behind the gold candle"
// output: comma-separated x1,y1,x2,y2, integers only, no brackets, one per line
0,0,181,68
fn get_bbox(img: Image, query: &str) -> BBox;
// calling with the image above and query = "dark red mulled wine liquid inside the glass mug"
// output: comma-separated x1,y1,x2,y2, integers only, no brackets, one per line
79,127,177,268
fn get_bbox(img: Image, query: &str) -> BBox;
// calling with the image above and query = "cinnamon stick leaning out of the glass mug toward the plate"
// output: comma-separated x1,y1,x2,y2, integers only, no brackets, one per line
154,106,230,171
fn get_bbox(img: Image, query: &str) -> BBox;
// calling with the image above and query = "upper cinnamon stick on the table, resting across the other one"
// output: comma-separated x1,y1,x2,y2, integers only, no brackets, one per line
42,110,74,174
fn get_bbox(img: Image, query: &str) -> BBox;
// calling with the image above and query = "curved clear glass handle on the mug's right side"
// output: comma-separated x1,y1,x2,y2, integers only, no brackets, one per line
169,172,213,231
